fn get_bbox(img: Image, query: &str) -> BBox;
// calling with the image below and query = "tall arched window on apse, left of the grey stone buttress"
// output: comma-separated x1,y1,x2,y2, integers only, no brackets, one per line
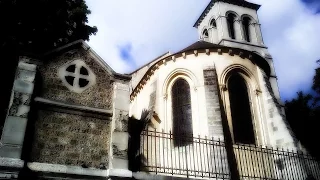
171,78,193,146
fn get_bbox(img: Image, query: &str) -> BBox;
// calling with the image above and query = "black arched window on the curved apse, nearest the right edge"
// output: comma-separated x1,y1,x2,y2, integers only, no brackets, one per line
228,74,255,144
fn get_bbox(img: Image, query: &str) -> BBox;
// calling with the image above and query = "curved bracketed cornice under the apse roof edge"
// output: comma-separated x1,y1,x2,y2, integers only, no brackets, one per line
130,47,270,101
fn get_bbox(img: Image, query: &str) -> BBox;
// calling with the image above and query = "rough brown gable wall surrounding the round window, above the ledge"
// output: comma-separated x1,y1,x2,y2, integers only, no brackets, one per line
39,47,113,109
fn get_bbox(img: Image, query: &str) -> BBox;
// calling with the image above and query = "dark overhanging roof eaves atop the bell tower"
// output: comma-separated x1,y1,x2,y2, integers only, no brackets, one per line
193,0,261,27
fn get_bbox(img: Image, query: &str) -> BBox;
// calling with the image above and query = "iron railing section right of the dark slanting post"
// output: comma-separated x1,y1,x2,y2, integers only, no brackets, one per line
233,145,320,180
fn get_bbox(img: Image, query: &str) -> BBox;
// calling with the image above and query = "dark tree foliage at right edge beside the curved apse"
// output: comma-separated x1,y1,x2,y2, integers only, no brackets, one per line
285,61,320,159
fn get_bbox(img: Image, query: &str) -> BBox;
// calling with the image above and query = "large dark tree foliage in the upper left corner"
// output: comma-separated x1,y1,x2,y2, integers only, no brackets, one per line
0,0,97,53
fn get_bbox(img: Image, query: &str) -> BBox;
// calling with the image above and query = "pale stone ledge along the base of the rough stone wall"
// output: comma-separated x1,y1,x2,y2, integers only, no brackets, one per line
27,162,108,177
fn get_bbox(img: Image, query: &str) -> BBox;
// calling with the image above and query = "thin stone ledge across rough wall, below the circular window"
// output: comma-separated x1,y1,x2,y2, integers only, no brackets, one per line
34,97,113,119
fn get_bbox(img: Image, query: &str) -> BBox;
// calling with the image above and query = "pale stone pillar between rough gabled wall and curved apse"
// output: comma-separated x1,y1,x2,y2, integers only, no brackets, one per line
109,82,132,177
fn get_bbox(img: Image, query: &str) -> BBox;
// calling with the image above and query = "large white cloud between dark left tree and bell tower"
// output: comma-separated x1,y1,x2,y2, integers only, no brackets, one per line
87,0,210,73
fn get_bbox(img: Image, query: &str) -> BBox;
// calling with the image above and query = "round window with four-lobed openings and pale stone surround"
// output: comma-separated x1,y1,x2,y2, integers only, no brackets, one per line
58,60,95,93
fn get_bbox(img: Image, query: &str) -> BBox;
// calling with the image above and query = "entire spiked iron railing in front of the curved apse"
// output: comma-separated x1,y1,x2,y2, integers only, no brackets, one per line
140,130,320,180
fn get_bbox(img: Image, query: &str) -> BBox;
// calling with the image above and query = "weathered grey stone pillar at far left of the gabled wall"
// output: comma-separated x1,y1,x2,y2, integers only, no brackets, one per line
0,59,37,159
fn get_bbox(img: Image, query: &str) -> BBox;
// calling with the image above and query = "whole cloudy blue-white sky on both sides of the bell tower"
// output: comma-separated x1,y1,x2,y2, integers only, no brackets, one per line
86,0,320,100
